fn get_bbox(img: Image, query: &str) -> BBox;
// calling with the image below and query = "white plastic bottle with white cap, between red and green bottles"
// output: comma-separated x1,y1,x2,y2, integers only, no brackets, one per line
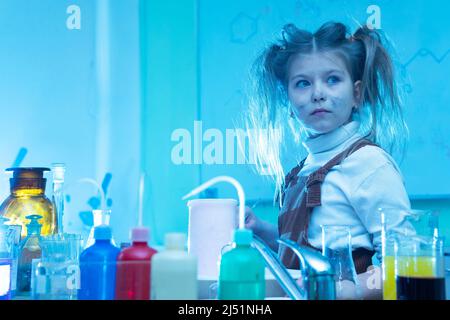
151,233,198,300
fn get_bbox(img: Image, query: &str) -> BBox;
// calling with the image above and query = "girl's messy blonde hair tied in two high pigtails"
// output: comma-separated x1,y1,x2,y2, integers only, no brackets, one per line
245,22,408,200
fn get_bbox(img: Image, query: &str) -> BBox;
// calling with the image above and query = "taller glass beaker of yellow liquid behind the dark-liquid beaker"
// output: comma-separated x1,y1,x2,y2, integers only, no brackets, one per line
376,208,439,300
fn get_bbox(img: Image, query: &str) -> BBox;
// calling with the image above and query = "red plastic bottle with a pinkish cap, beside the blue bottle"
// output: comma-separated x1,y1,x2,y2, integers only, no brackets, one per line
115,227,157,300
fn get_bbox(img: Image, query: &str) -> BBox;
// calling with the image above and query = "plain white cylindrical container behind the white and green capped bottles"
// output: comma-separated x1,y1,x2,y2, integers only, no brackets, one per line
188,199,238,279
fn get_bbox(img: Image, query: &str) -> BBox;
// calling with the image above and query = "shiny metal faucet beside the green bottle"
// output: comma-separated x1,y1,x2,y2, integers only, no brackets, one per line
252,235,336,300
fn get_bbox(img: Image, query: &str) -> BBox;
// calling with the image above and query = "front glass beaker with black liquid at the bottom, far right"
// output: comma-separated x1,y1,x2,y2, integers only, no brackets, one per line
396,235,445,300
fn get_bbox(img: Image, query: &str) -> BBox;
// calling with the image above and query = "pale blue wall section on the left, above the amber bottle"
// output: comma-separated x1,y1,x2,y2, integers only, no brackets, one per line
0,0,140,241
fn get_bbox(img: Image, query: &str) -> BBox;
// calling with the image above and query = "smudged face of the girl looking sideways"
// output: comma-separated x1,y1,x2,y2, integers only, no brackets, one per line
288,52,361,136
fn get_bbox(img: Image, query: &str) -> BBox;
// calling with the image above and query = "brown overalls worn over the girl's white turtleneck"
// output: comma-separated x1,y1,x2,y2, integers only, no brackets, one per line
278,139,376,274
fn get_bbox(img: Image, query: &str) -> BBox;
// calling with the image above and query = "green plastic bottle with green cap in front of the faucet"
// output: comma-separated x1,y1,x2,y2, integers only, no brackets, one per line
218,229,266,300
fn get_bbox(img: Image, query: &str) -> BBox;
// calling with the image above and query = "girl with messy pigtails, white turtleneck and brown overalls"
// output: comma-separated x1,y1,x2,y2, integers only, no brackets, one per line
247,22,410,299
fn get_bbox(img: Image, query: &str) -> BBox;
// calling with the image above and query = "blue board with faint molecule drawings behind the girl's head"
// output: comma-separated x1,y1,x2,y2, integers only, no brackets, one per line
199,0,450,198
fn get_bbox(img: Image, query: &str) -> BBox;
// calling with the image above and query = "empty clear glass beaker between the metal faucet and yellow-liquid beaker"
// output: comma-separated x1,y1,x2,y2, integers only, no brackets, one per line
322,225,361,299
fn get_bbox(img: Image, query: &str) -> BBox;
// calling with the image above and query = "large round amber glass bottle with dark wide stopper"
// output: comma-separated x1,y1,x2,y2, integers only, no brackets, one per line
0,168,58,238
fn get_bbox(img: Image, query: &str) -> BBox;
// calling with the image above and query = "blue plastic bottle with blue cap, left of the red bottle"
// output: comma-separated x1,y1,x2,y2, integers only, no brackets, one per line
78,225,120,300
